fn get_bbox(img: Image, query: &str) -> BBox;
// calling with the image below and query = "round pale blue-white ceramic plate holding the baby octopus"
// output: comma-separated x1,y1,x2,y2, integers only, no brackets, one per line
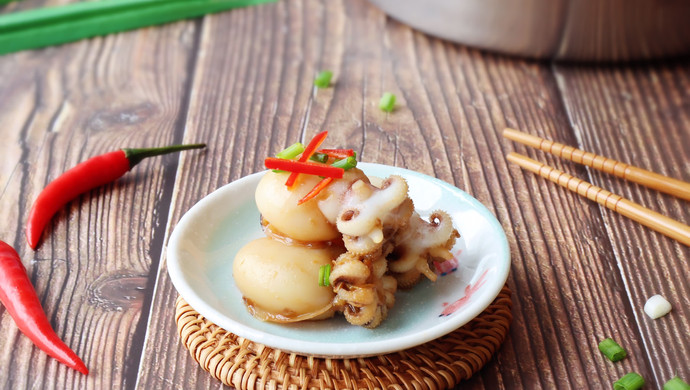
167,163,510,357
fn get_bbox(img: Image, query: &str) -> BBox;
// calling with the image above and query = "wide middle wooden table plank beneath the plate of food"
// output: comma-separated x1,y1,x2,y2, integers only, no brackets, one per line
133,0,668,389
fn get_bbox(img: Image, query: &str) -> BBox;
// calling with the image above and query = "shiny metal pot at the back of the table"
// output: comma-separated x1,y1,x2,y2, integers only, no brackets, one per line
370,0,690,62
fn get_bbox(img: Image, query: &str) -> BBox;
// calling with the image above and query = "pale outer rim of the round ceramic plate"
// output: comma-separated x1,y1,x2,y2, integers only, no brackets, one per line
166,162,511,358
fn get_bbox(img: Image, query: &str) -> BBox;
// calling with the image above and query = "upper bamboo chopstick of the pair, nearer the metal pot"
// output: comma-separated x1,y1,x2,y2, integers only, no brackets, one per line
503,129,690,200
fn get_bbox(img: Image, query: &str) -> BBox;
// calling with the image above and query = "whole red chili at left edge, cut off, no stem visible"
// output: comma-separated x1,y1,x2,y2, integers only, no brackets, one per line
0,241,89,375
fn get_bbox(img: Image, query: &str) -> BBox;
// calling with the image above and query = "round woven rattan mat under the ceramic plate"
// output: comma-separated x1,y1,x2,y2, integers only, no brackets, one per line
175,286,512,390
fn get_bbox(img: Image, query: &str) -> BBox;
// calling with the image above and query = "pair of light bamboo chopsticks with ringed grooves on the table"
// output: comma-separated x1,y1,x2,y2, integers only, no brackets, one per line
503,129,690,246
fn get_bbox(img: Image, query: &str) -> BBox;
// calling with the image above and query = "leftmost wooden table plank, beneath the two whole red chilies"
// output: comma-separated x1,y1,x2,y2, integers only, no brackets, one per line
0,14,196,389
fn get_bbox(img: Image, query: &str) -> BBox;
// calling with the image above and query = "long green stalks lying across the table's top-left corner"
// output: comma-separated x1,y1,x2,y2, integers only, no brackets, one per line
0,0,276,54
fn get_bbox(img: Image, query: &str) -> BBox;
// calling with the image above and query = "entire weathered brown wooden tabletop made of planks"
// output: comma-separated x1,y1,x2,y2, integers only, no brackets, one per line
0,0,690,389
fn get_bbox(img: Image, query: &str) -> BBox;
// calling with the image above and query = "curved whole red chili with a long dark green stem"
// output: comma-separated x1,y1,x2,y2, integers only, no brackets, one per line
26,144,206,249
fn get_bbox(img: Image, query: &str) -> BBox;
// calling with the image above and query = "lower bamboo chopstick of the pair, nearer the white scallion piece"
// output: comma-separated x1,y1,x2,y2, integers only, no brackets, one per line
506,152,690,246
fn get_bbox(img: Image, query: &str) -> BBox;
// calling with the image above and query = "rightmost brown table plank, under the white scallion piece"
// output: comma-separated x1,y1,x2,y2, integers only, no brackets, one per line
555,62,690,388
